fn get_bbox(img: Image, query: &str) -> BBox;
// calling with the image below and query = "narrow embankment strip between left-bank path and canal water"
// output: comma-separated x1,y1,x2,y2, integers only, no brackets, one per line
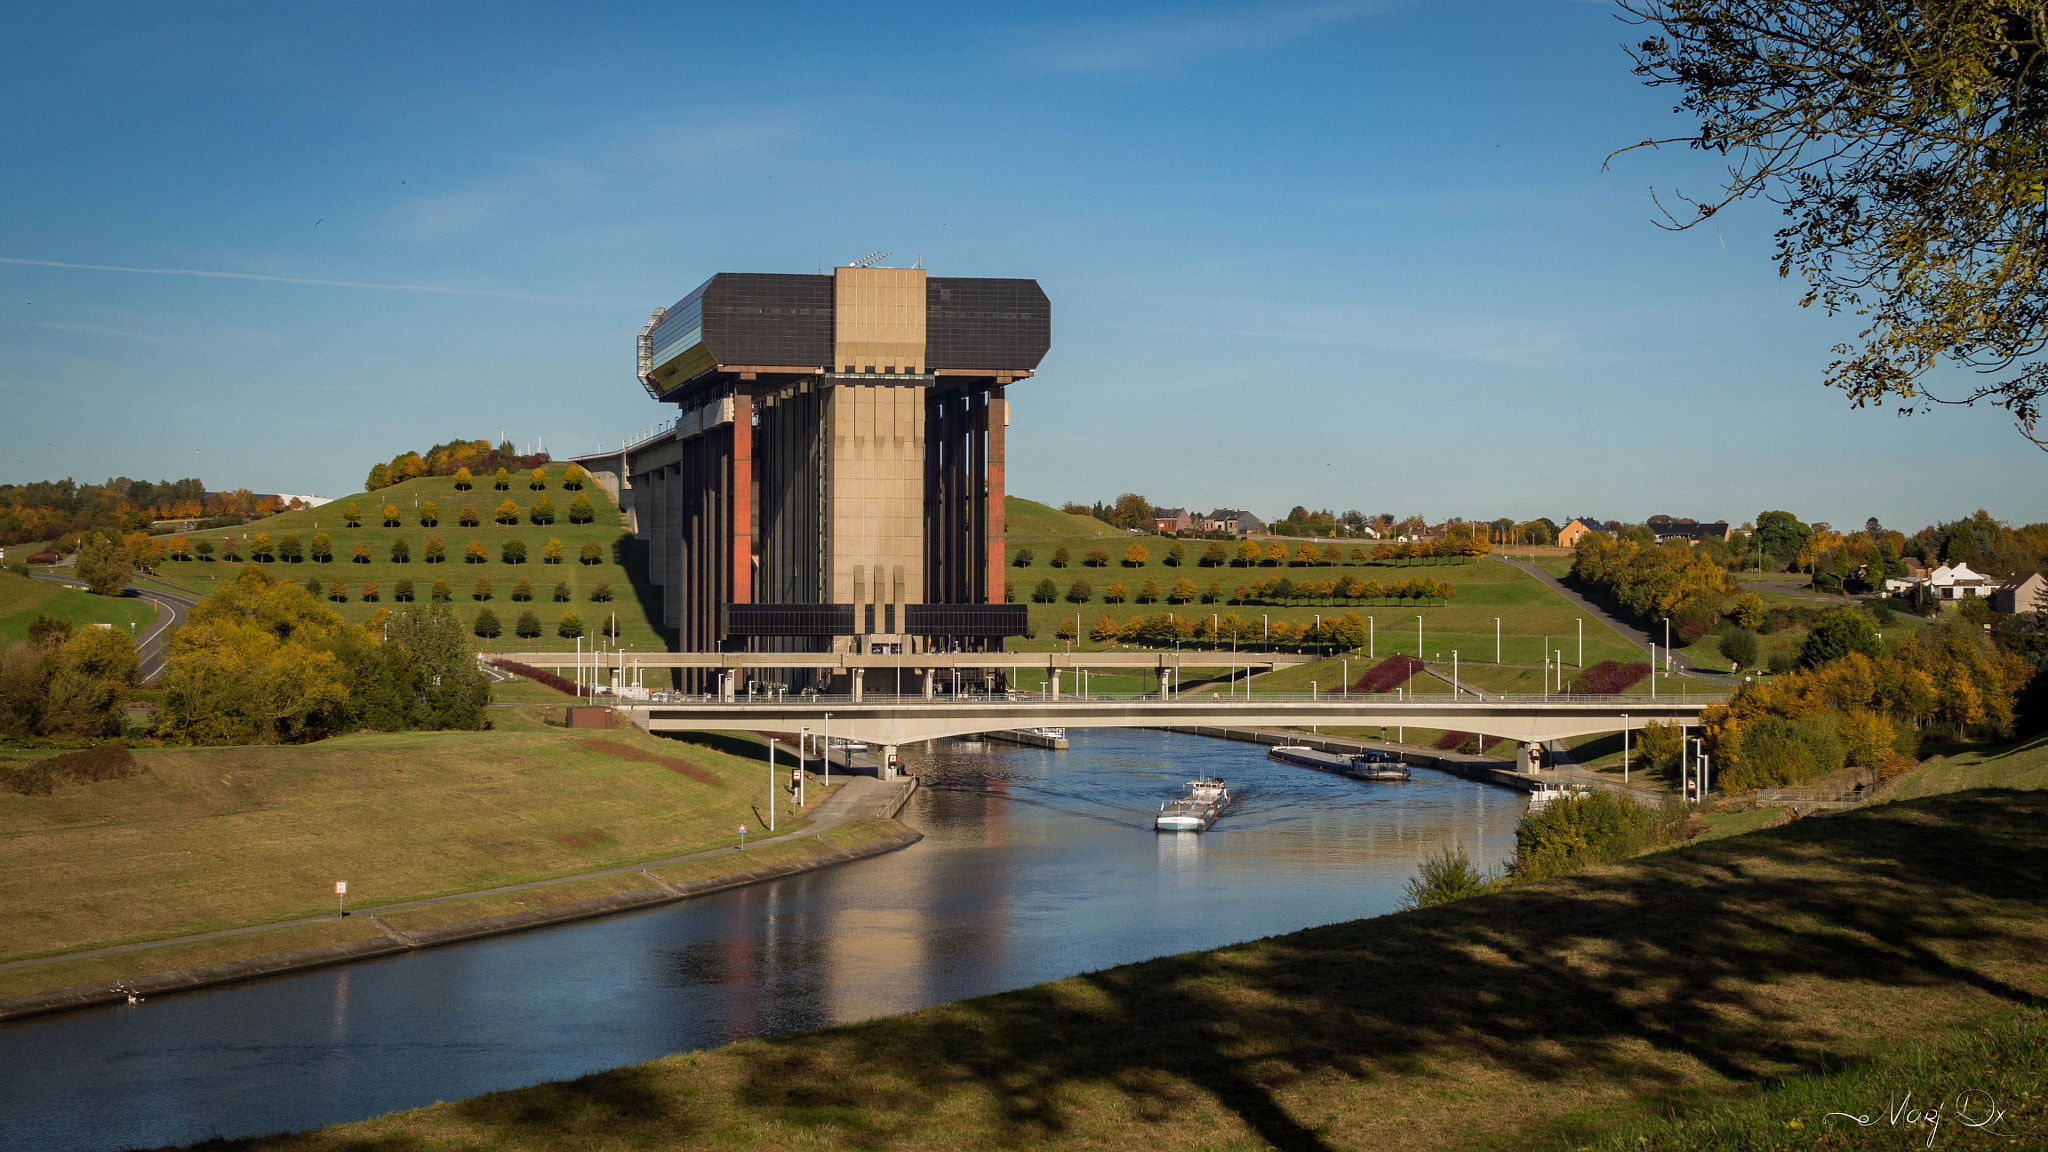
0,777,922,1021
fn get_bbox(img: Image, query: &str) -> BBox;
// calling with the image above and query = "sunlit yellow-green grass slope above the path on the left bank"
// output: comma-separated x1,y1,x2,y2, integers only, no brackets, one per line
0,709,815,967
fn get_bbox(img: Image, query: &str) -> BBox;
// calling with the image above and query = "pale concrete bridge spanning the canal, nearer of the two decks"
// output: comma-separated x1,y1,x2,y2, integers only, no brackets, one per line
618,693,1724,765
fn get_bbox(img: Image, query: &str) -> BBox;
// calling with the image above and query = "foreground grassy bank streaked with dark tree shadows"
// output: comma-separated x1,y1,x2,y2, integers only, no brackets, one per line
195,789,2048,1152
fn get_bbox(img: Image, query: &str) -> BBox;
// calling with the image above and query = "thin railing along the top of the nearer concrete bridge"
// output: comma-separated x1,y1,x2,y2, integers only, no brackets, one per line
614,691,1729,707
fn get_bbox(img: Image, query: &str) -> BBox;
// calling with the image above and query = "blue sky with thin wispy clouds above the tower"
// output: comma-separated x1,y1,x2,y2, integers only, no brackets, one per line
0,0,2048,531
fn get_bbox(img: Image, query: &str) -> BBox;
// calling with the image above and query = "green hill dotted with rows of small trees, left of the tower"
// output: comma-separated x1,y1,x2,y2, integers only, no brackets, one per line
158,465,668,652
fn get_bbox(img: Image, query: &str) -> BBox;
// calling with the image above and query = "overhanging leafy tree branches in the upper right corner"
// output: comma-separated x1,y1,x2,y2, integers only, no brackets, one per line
1618,0,2048,449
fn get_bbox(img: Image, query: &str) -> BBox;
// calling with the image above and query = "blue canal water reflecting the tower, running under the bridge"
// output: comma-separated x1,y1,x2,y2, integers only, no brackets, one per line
0,730,1524,1152
